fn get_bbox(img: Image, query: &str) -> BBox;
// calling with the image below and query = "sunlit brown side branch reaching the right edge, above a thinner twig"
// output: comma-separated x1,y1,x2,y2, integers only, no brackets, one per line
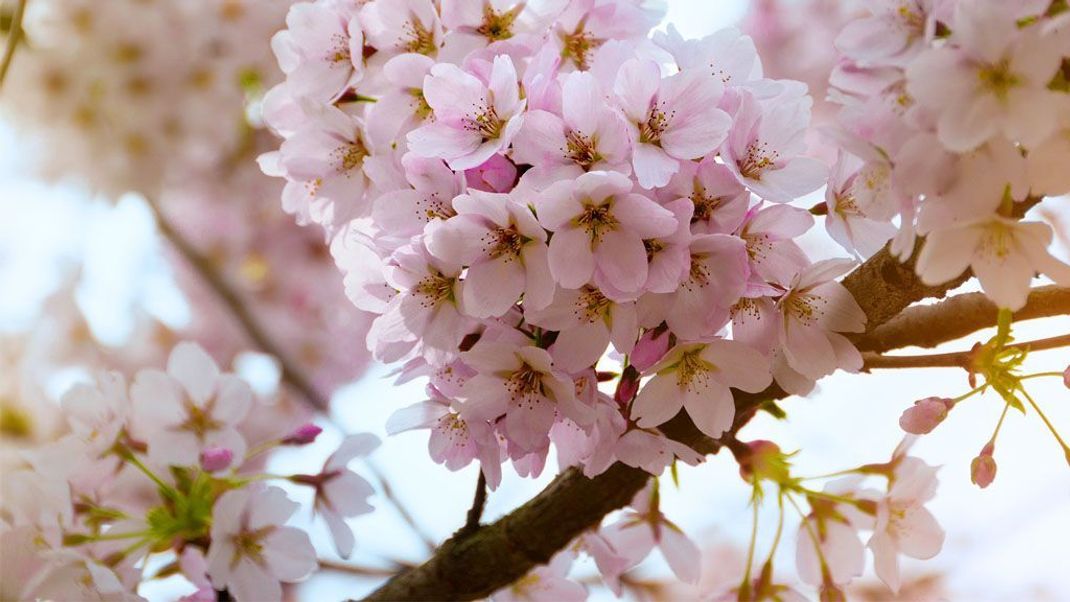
855,287,1070,353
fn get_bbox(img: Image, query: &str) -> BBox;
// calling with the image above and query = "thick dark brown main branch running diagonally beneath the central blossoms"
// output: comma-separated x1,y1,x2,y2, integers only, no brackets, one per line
366,242,984,600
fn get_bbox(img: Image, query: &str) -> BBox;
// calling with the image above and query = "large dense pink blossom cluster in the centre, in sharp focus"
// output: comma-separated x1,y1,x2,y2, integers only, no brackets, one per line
260,0,866,496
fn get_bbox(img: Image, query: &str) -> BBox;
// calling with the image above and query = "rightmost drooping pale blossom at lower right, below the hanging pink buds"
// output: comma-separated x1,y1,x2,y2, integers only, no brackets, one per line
868,458,944,591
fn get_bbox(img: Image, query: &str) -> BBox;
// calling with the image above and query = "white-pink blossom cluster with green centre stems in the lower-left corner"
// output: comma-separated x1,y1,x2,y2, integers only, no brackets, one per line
0,343,378,601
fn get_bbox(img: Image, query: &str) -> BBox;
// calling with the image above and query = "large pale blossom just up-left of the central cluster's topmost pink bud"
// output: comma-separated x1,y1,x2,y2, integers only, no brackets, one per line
408,55,525,170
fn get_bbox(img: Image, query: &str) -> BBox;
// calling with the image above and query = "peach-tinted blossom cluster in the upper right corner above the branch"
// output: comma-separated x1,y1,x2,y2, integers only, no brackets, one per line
826,0,1070,310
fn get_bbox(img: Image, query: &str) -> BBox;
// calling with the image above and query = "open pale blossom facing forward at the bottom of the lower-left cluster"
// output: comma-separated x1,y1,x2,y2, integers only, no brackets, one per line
207,485,316,602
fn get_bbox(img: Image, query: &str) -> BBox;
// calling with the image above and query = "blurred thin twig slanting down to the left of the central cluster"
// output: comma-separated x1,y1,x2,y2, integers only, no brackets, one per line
146,198,434,551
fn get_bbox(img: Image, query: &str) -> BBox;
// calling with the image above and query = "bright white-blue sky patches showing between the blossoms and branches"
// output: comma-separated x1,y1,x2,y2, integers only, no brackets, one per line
0,0,1070,601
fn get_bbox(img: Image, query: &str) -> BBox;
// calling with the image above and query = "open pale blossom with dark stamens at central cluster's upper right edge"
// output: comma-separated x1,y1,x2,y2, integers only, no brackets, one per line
720,92,828,203
